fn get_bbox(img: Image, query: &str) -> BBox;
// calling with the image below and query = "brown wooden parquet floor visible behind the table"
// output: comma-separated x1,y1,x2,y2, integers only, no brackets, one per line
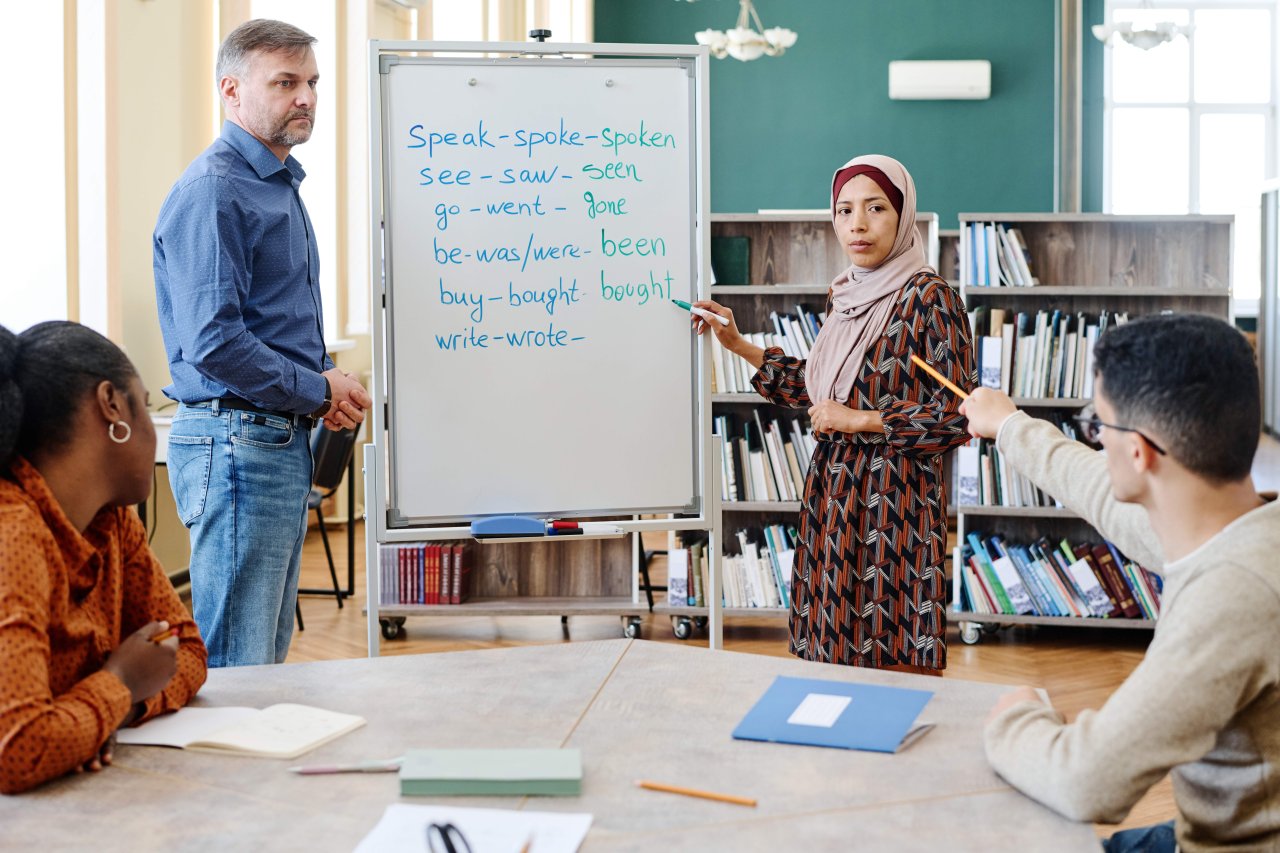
288,437,1280,835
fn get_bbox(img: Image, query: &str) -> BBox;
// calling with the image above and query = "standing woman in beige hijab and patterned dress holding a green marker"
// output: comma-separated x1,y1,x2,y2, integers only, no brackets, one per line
694,155,975,675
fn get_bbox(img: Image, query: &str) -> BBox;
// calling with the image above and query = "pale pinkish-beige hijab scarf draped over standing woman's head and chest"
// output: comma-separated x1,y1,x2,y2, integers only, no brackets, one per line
805,154,934,403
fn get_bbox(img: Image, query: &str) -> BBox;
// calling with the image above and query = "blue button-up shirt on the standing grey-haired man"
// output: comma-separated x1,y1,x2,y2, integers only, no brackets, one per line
152,122,333,414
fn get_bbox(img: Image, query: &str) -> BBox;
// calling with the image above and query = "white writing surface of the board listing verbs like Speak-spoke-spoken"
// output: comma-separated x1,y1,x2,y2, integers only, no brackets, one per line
379,55,705,526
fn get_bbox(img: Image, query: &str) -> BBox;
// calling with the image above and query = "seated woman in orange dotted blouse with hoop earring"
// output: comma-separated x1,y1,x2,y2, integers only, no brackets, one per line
0,321,205,794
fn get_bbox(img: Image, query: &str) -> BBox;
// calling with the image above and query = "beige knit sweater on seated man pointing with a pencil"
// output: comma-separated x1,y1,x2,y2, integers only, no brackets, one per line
986,412,1280,850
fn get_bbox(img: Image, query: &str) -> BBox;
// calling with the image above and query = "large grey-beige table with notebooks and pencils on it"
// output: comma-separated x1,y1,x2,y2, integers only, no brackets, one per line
0,639,1098,853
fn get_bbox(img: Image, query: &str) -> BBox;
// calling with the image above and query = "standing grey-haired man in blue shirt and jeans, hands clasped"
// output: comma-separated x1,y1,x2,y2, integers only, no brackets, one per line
152,19,371,666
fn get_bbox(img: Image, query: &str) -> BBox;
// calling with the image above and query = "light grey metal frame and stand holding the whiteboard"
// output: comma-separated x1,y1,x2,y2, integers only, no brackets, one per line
364,40,723,657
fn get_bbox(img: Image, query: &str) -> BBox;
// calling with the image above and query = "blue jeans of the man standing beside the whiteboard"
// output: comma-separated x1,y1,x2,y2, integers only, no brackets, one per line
169,402,311,666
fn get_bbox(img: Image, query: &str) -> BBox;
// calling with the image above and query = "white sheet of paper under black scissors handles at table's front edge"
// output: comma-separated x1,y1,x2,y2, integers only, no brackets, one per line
356,803,591,853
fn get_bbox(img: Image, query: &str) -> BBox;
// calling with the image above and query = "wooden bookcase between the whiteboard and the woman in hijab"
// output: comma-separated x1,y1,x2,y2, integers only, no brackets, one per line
653,210,938,639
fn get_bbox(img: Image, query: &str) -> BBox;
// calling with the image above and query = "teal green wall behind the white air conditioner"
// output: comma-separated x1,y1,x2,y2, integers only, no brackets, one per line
595,0,1080,228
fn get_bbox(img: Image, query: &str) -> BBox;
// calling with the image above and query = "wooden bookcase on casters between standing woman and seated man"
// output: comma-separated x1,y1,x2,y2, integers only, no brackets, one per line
948,213,1233,643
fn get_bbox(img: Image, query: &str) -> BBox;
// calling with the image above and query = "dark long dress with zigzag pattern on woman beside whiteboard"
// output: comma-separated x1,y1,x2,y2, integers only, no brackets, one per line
753,273,974,670
